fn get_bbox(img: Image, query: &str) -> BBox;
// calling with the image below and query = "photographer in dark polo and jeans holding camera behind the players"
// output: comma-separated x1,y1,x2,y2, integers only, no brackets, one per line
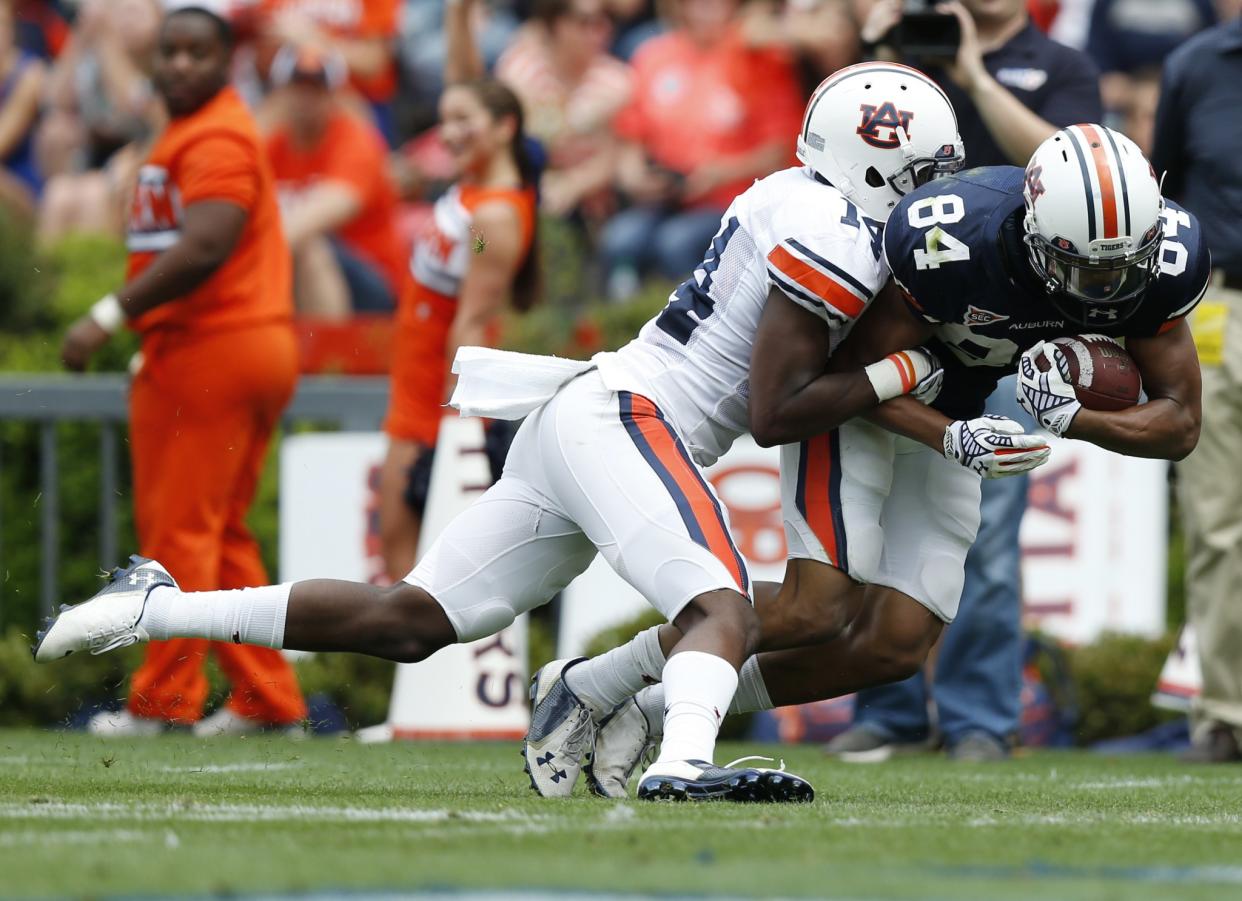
826,0,1102,761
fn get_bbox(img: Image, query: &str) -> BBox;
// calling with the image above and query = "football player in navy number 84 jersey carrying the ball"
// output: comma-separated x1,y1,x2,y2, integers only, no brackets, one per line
591,124,1211,797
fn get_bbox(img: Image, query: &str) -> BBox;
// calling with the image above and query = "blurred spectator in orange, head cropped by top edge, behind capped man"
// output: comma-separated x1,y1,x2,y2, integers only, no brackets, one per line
241,0,401,143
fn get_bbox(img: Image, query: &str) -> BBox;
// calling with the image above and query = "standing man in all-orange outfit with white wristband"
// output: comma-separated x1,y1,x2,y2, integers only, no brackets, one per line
61,0,306,734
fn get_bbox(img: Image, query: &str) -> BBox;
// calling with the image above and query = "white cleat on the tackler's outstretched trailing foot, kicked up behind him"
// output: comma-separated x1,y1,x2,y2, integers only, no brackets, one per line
32,554,176,664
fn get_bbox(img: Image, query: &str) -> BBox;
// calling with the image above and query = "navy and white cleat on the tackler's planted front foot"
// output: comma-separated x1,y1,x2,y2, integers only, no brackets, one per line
638,757,815,803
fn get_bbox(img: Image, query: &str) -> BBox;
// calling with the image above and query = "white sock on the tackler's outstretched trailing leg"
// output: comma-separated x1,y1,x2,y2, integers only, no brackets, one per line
139,582,293,647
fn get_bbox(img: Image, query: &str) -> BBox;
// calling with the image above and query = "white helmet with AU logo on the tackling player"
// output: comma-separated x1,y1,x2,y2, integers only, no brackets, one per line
797,62,964,222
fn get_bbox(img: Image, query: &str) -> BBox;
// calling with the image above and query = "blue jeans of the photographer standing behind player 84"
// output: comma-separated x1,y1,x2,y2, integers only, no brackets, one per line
854,377,1033,747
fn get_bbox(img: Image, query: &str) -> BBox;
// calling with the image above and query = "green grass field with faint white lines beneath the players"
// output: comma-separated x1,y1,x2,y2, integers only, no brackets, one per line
0,731,1242,901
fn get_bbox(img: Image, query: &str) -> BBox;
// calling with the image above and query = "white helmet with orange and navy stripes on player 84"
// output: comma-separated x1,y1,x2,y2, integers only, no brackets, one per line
1023,124,1164,327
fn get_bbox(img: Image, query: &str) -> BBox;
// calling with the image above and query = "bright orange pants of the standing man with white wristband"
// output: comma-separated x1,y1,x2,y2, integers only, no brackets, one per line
129,323,306,723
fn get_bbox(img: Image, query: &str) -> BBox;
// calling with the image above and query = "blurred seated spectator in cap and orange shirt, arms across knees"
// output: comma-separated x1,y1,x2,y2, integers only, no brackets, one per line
267,47,410,318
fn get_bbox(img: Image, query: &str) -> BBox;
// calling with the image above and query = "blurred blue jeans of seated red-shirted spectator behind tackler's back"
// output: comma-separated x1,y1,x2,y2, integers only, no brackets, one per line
600,206,723,281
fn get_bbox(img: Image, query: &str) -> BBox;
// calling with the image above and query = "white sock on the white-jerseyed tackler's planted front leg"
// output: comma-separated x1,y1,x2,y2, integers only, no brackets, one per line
658,651,738,763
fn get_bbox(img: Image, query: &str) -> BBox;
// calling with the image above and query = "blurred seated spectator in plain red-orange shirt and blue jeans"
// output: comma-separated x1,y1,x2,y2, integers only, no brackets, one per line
600,0,802,298
